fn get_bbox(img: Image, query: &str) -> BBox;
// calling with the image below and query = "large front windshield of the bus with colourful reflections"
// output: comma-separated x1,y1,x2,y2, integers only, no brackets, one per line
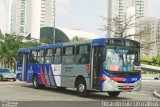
104,48,139,72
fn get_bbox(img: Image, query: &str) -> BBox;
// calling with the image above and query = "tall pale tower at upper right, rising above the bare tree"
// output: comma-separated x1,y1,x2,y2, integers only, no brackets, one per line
107,0,148,37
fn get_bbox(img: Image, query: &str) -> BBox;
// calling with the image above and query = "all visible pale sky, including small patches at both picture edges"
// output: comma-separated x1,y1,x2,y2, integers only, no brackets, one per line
0,0,160,35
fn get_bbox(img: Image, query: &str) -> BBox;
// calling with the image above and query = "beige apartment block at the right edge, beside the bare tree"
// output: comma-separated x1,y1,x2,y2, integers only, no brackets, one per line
135,17,160,56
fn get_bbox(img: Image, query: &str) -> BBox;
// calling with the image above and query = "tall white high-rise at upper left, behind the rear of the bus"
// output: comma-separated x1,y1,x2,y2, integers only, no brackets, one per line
11,0,54,39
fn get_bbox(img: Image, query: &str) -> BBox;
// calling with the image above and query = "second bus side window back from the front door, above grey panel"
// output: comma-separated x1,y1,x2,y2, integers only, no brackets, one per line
62,46,75,64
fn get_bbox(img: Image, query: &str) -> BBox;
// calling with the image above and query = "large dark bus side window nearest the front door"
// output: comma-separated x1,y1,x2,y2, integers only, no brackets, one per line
76,45,90,64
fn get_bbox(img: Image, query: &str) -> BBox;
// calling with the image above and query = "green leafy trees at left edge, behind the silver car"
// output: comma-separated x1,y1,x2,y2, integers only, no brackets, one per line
0,34,41,72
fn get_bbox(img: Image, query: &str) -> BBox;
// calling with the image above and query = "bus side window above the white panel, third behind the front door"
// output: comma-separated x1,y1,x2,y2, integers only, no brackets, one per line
54,48,62,64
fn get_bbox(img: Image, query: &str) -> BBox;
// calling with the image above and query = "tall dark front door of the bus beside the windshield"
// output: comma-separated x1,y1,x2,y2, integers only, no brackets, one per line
92,46,102,90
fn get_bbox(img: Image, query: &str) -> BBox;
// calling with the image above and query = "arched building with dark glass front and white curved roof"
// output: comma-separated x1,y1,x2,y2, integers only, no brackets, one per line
40,27,102,43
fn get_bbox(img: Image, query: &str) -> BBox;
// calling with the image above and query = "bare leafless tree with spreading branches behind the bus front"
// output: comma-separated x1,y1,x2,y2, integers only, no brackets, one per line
100,15,155,54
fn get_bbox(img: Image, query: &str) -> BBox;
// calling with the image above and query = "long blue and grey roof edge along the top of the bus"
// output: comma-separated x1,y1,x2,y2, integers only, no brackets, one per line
19,38,139,52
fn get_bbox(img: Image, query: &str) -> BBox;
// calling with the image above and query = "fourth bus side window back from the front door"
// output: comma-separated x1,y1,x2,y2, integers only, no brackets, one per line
45,49,54,64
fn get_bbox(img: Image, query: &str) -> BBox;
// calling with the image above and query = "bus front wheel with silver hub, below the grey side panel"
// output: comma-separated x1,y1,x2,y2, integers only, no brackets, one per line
76,79,88,97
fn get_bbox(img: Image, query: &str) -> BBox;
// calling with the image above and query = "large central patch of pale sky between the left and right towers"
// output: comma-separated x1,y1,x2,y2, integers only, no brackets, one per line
56,0,107,35
